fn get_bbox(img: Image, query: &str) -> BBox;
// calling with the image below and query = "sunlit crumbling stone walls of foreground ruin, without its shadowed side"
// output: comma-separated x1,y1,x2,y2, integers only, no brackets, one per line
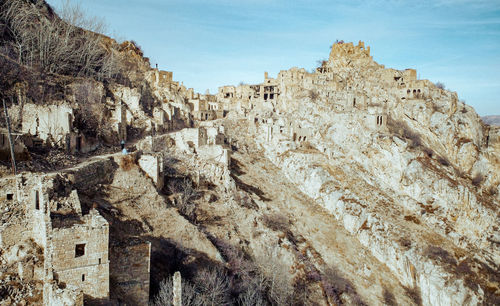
0,174,109,305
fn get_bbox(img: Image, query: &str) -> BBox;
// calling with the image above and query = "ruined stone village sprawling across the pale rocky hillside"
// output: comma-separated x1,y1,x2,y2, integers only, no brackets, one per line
0,33,500,305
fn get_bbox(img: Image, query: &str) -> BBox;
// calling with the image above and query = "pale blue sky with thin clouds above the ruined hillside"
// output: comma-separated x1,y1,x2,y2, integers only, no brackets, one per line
48,0,500,116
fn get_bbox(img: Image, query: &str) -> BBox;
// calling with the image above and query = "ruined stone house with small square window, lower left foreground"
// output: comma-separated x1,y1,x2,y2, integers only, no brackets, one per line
11,175,109,300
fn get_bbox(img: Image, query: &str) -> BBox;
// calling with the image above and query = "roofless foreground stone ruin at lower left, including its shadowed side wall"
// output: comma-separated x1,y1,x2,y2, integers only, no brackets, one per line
0,170,150,305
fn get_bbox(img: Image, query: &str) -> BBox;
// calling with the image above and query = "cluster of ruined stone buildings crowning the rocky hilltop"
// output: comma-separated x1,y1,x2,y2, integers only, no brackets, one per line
213,41,440,141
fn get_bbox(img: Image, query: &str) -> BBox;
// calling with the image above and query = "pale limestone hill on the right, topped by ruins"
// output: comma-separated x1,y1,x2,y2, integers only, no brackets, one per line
222,42,500,305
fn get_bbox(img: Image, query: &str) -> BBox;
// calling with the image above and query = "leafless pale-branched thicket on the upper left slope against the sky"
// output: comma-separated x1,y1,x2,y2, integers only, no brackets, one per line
0,0,119,78
